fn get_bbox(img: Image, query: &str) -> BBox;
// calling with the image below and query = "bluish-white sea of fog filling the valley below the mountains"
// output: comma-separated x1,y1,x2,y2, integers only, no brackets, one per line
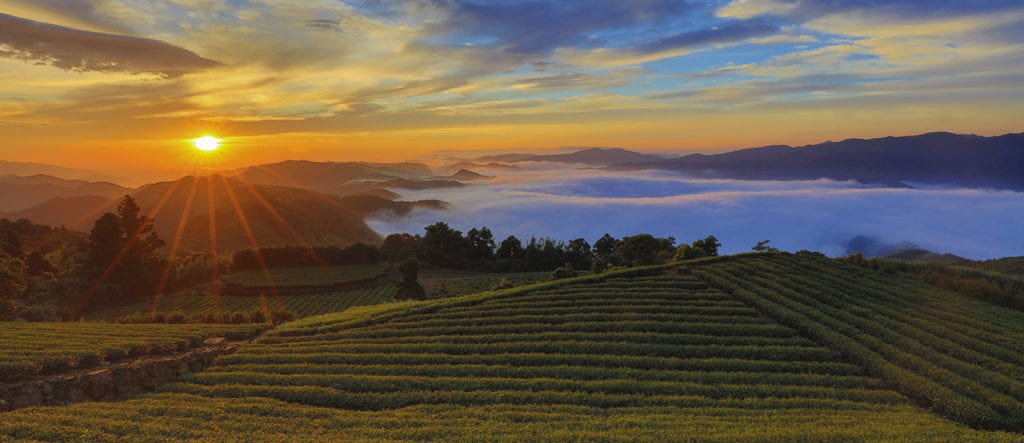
370,165,1024,259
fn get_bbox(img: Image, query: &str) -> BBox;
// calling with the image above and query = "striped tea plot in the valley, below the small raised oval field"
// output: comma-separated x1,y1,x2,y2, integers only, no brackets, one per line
87,284,395,320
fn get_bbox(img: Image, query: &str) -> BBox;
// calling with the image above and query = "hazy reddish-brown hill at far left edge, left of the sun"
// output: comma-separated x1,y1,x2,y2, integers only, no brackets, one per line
0,174,132,212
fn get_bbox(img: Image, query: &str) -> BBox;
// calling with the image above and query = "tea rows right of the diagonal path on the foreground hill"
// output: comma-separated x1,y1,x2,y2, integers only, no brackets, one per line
697,255,1024,430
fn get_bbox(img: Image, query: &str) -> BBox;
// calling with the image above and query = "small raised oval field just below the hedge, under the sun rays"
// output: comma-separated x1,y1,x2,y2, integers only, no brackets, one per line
222,265,387,287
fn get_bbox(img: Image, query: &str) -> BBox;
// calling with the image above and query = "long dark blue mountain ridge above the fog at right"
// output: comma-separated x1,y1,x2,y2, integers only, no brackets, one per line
612,132,1024,190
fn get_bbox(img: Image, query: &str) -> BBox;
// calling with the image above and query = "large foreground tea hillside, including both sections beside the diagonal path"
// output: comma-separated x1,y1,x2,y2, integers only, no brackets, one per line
8,255,1024,435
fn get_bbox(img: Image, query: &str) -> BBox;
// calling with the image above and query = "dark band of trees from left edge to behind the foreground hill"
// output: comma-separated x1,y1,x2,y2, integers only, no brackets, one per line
0,195,733,320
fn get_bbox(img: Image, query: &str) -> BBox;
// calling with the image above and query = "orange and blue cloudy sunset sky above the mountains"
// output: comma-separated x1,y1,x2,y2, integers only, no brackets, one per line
0,0,1024,178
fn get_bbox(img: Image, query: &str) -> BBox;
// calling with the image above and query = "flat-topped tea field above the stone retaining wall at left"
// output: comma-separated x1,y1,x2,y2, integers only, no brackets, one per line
0,321,267,381
